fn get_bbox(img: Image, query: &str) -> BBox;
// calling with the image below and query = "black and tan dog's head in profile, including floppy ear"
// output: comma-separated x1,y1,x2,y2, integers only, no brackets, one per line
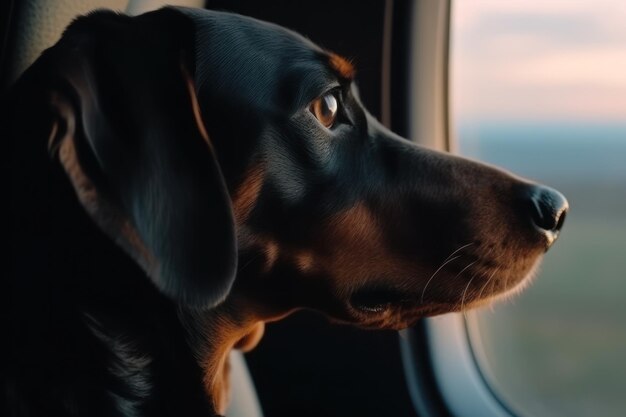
8,9,567,328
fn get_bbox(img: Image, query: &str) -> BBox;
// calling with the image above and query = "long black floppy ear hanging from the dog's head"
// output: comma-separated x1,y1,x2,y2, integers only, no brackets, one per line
11,9,237,307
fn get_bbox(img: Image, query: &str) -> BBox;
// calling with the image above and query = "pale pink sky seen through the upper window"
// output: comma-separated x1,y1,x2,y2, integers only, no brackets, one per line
451,0,626,123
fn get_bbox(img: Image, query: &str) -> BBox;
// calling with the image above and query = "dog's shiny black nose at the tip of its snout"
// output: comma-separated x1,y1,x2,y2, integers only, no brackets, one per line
530,185,569,247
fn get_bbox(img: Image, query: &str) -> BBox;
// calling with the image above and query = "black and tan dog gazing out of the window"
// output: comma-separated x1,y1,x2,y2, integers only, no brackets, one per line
1,8,568,416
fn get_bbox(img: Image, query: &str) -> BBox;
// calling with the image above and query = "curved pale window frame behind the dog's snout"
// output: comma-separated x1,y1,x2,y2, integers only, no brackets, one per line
394,0,517,417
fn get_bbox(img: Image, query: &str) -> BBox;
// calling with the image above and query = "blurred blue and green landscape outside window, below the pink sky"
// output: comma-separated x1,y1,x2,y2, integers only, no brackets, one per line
456,121,626,417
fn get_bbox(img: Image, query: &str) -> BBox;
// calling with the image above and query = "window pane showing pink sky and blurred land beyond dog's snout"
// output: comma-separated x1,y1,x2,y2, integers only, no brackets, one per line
451,0,626,417
